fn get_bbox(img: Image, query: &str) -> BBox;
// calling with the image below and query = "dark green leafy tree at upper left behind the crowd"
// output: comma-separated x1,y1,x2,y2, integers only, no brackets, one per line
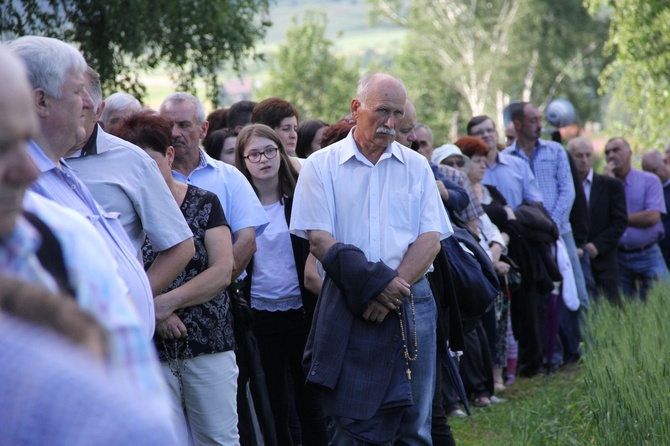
0,0,270,102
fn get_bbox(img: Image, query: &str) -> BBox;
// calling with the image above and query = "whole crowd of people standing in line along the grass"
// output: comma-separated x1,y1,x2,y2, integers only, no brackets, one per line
0,36,670,446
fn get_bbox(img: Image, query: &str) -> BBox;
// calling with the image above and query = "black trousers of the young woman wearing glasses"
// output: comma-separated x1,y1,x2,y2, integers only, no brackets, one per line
253,310,328,446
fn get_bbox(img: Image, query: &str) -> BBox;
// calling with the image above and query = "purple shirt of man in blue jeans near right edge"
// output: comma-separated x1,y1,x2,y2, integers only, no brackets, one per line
619,169,666,249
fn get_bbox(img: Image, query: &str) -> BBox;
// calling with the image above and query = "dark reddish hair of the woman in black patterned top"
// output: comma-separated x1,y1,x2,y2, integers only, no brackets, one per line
116,110,172,155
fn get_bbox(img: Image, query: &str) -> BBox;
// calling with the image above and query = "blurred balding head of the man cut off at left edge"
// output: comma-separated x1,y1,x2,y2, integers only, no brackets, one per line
0,47,39,239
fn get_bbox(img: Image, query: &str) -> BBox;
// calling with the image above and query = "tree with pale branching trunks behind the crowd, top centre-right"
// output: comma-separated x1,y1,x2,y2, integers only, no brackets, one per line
368,0,606,138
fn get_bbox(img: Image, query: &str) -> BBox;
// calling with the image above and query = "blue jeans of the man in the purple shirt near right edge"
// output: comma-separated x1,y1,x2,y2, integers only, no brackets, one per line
618,243,668,300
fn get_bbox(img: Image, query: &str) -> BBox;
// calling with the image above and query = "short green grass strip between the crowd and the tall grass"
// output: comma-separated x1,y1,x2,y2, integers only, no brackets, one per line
450,365,590,446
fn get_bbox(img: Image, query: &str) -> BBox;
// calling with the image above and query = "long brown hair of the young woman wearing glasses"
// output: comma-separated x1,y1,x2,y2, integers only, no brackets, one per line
235,124,298,197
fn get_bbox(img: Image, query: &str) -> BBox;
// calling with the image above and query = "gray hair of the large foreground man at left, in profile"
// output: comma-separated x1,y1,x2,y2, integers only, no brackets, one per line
6,36,87,99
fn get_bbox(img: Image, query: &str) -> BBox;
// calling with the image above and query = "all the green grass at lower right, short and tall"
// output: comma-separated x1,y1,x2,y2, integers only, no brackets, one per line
451,284,670,446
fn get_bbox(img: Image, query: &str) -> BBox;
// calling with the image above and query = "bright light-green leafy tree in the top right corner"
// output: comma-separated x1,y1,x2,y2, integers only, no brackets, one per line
585,0,670,149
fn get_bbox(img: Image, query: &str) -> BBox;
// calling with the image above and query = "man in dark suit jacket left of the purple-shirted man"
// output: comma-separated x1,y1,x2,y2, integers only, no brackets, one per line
568,137,628,302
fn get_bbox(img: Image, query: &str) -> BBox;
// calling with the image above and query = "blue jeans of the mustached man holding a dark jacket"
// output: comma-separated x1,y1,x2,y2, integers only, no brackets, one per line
329,278,437,446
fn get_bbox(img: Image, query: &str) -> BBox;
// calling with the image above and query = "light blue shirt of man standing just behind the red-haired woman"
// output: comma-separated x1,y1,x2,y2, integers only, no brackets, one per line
482,152,542,209
